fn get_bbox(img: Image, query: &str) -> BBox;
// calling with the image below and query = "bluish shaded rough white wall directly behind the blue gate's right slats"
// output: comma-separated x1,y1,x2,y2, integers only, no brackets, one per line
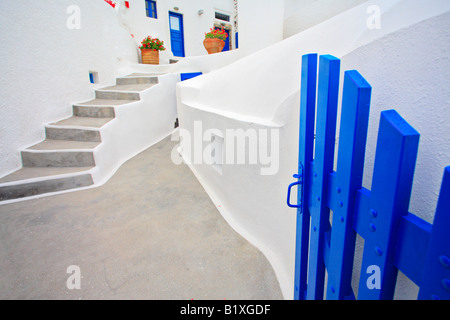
342,11,450,299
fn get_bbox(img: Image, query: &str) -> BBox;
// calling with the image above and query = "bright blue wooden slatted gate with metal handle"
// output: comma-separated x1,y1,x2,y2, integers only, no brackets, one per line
287,54,450,300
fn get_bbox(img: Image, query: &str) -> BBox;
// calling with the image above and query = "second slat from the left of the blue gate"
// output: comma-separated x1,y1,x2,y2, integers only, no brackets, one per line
307,55,340,300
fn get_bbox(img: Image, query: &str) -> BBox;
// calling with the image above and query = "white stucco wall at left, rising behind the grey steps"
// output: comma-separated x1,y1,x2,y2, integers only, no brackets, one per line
0,0,138,176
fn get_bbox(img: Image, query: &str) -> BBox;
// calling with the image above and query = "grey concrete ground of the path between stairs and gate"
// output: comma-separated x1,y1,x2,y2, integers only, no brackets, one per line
0,138,282,300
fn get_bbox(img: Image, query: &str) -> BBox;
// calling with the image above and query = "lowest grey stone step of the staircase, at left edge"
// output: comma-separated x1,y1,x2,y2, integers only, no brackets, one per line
0,167,94,201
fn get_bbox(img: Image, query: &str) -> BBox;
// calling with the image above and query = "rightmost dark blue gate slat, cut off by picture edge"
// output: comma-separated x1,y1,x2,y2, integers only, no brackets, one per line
418,167,450,300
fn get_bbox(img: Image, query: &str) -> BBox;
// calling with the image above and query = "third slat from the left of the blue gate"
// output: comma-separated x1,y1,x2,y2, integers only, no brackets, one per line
327,71,372,300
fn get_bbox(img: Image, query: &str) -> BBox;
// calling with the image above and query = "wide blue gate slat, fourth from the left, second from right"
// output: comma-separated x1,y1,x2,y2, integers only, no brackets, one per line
358,110,419,300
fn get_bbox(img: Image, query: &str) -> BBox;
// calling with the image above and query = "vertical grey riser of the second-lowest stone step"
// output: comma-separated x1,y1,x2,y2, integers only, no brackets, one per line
21,149,95,167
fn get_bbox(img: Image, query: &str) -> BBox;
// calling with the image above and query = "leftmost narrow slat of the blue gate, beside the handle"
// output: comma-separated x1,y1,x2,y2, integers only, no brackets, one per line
294,54,317,300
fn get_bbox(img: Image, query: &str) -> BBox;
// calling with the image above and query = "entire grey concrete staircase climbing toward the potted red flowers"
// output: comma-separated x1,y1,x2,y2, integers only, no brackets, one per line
0,74,158,201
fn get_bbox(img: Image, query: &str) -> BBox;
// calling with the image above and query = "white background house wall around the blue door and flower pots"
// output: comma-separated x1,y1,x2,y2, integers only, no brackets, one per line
119,0,235,63
